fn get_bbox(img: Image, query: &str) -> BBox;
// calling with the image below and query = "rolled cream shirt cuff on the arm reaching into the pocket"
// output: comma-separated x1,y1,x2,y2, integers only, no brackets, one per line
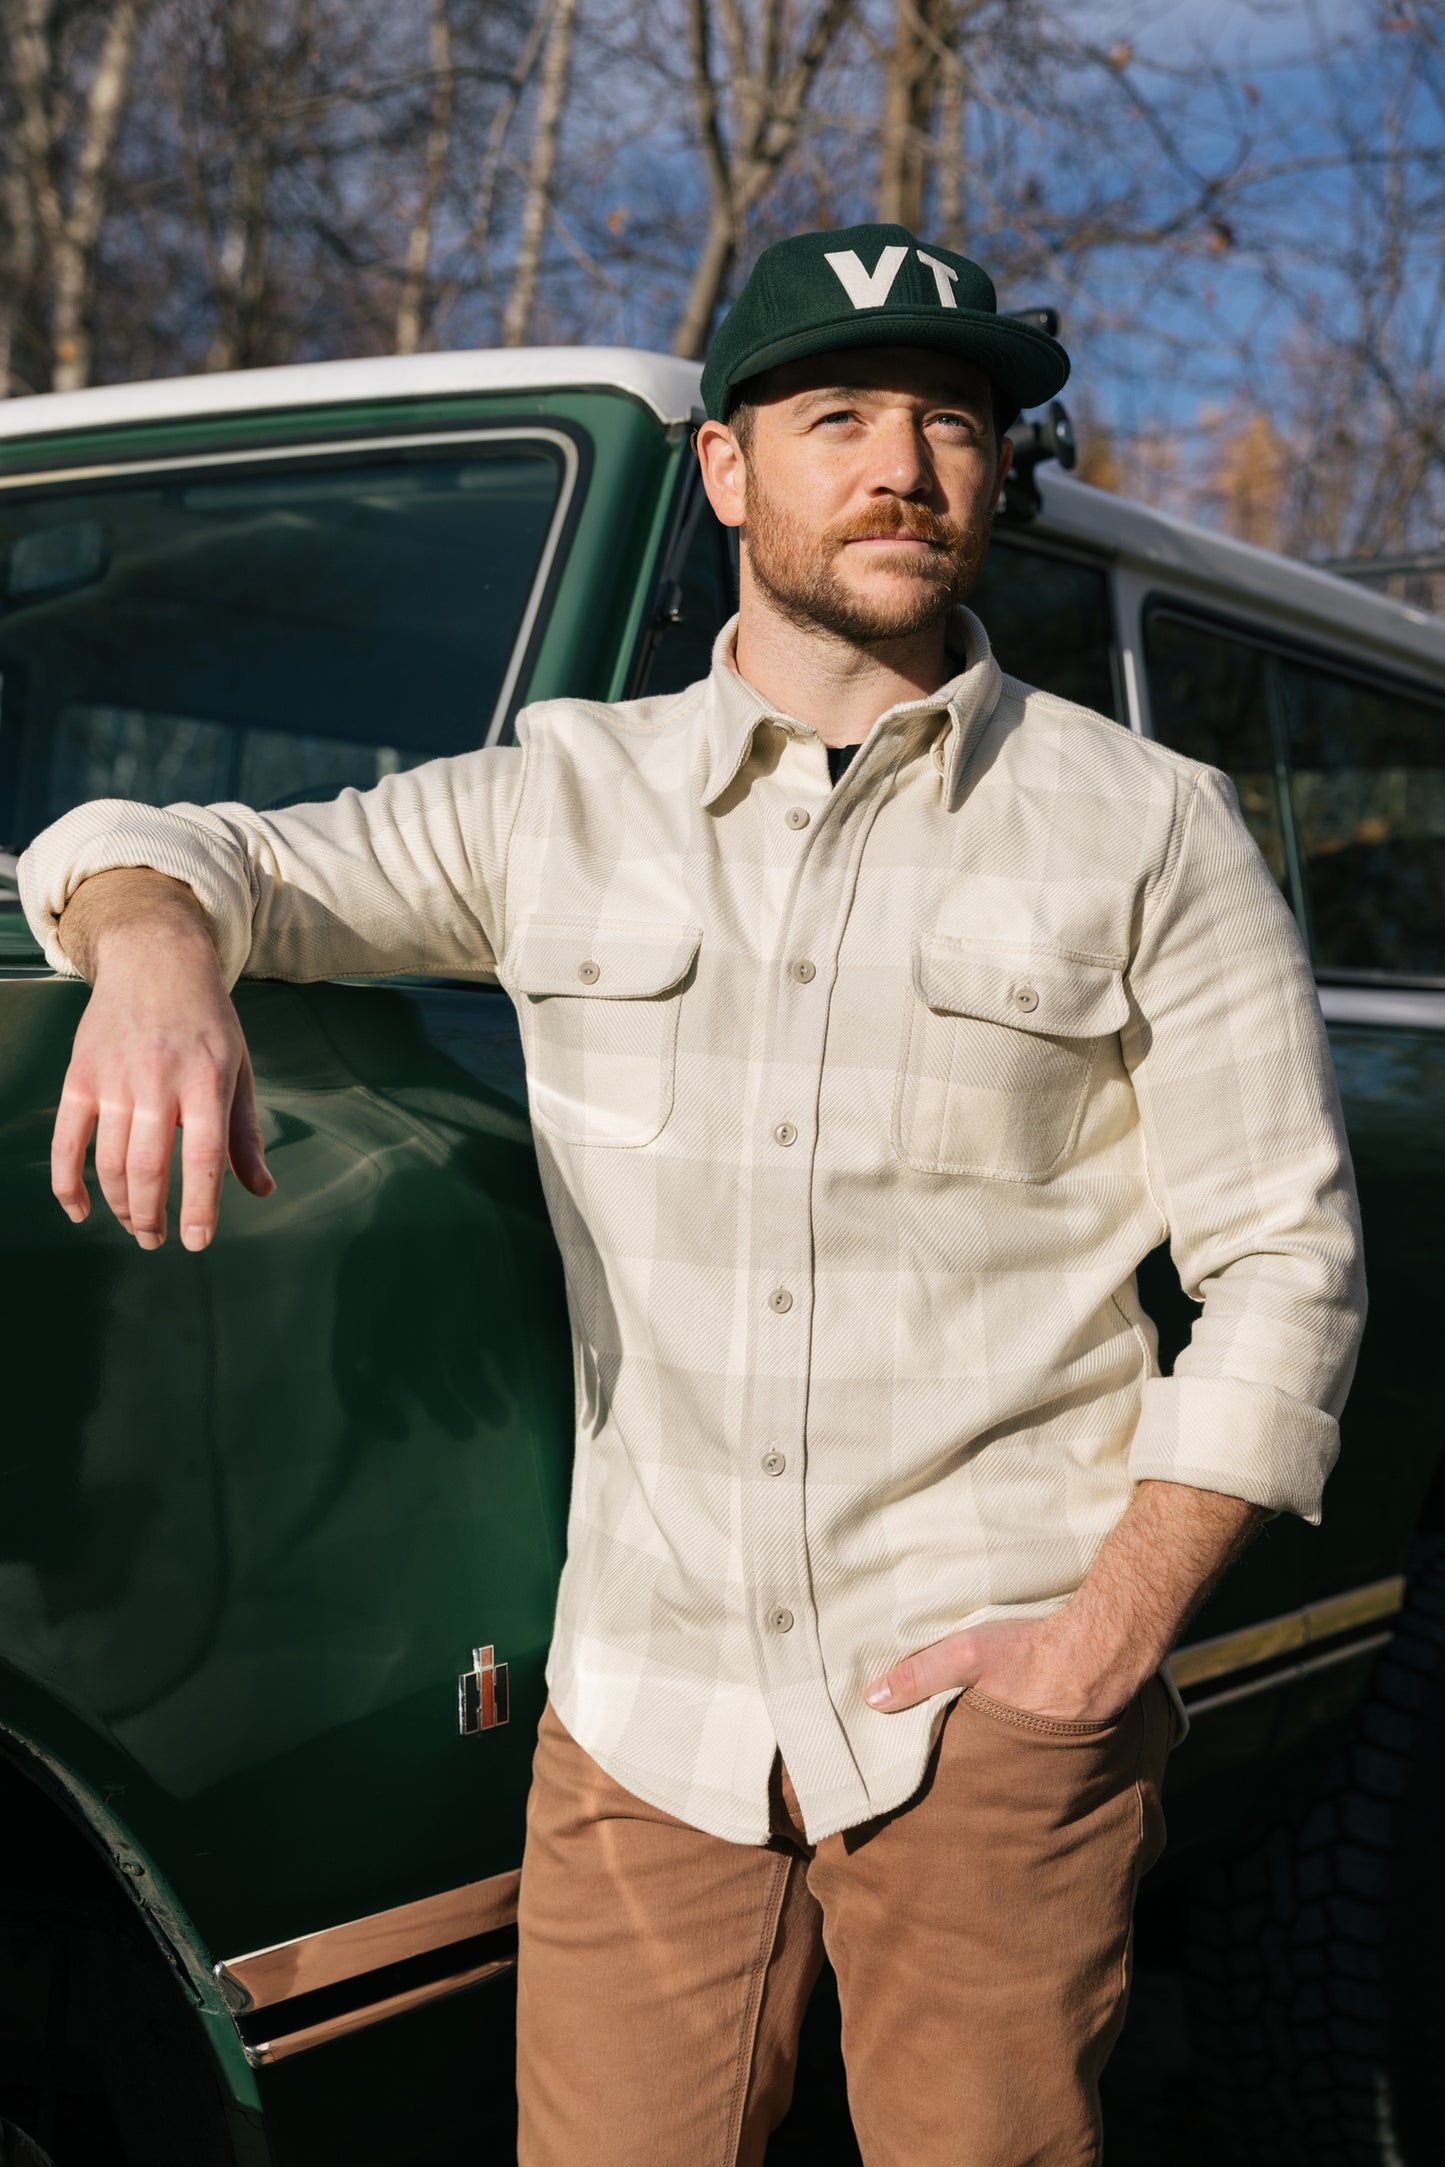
1129,1376,1339,1528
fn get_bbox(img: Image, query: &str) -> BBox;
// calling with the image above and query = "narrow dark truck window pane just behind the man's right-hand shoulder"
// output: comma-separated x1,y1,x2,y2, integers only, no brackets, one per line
1144,609,1293,899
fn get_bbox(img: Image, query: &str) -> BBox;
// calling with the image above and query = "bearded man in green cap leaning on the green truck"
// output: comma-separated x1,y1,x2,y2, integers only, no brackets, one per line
22,228,1363,2167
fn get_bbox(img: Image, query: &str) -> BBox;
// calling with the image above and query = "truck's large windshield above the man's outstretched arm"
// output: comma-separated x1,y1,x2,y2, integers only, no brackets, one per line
0,431,576,849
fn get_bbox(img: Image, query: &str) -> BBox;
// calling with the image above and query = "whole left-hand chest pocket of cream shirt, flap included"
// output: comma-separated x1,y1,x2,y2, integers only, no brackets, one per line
503,919,702,1144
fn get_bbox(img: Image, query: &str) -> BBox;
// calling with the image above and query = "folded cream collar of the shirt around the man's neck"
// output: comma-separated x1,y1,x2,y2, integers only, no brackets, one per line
702,605,1001,806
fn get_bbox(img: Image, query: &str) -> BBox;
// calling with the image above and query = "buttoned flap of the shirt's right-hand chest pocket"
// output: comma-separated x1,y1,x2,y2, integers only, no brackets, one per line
914,934,1129,1038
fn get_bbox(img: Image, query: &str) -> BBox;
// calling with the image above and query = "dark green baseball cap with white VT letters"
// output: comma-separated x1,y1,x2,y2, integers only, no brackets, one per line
702,225,1068,420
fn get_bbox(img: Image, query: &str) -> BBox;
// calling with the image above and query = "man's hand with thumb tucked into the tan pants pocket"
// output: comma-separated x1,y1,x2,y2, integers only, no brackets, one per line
864,1610,1153,1723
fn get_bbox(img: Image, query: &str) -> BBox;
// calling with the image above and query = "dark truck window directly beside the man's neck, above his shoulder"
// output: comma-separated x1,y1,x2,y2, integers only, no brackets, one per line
966,535,1120,722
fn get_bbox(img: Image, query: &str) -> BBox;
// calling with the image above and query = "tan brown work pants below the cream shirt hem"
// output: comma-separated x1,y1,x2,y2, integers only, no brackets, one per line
518,1679,1172,2167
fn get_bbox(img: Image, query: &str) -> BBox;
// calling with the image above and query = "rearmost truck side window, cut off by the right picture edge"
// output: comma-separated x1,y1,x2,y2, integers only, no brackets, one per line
1272,654,1445,979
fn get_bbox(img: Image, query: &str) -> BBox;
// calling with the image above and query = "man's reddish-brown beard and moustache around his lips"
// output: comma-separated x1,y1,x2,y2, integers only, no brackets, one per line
743,472,990,648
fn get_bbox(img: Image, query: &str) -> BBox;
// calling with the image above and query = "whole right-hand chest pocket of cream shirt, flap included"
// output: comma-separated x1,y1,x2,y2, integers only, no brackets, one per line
893,934,1129,1181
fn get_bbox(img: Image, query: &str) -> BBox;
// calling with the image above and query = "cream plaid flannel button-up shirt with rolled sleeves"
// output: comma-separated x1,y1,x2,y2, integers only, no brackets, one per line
22,611,1363,1842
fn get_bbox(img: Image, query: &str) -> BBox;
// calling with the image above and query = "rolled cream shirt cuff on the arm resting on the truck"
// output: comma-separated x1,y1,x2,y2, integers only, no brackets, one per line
15,797,251,986
